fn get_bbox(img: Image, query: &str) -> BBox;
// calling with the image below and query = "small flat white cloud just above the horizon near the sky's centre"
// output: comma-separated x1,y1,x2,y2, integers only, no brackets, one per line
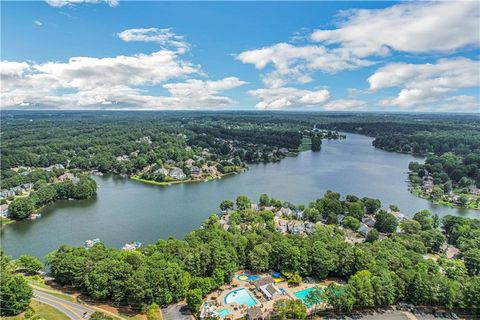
248,87,330,110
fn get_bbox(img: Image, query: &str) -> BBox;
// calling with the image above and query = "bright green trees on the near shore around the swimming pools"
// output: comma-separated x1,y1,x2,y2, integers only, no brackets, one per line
12,192,480,313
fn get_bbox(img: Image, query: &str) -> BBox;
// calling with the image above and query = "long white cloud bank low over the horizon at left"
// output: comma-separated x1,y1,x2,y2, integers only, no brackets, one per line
0,50,245,109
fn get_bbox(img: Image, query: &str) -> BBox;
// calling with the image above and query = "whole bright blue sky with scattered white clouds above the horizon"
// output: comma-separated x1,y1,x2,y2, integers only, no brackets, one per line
0,0,480,112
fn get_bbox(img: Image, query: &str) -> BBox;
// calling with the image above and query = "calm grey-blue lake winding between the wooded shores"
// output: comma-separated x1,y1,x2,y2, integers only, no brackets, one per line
1,134,480,257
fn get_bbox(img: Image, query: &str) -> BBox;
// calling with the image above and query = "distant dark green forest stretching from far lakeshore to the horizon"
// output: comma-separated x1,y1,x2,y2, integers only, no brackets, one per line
1,111,480,173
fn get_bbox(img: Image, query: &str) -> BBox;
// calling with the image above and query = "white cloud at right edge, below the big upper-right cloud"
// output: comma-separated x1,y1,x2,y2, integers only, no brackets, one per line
368,58,480,108
